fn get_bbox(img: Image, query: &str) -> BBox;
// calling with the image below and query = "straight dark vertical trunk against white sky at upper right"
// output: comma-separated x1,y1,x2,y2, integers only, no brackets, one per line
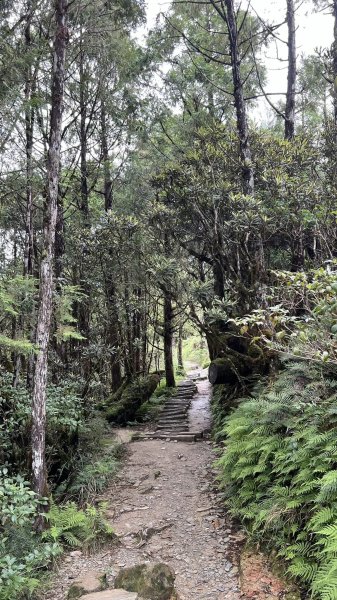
284,0,296,140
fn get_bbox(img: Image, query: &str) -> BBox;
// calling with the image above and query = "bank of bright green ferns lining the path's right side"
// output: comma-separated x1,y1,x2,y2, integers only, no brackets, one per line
218,363,337,600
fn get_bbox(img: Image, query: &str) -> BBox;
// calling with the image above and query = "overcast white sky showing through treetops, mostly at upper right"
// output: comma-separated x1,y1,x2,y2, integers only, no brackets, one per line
142,0,333,118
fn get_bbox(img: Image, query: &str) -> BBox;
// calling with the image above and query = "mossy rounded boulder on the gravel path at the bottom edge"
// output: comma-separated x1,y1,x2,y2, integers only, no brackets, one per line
115,563,177,600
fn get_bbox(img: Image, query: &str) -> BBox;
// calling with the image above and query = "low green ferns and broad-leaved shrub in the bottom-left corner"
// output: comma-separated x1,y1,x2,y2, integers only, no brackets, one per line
0,469,113,600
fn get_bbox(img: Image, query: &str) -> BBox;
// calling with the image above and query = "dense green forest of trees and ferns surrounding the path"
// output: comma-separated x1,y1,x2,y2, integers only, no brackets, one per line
0,0,337,600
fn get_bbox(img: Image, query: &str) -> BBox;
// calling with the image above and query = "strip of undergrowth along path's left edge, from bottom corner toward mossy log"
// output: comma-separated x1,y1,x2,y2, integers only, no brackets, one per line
0,417,123,600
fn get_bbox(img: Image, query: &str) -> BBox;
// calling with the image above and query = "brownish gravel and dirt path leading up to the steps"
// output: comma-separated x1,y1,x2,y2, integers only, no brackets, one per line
44,372,296,600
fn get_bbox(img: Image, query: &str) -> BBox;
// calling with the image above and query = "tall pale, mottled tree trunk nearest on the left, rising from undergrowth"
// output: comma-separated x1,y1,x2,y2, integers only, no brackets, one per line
32,0,68,516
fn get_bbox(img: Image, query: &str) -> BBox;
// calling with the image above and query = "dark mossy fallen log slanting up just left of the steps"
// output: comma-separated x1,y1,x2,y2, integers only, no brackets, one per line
105,374,160,425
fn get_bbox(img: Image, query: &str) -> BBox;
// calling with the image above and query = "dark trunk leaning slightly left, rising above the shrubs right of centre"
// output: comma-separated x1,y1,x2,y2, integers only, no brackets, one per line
225,0,254,195
